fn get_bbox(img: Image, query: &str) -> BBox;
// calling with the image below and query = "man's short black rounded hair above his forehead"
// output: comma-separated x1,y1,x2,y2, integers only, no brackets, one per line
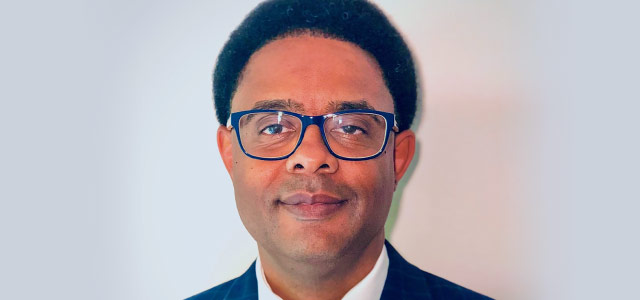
213,0,417,131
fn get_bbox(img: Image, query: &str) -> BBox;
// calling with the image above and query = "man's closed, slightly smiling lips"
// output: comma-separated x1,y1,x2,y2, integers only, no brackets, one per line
279,193,347,221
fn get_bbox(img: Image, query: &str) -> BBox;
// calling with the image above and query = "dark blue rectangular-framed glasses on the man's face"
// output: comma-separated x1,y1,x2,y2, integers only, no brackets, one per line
227,109,398,160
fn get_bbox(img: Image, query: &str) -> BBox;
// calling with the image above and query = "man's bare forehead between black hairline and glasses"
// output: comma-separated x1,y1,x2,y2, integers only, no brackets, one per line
231,35,393,115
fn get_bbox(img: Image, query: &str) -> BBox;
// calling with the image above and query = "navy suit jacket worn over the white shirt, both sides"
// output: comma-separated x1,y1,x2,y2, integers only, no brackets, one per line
188,241,491,300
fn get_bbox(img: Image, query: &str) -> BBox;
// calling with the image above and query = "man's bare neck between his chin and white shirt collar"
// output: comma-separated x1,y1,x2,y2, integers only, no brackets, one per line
258,231,384,299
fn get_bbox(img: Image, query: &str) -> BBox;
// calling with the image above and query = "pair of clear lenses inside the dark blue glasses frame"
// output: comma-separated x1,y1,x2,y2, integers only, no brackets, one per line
238,112,387,158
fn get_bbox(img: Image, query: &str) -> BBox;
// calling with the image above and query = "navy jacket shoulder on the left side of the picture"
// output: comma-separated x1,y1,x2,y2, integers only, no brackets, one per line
186,262,258,300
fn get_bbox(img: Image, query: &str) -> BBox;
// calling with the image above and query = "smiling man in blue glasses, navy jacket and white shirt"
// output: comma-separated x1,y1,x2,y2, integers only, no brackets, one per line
191,0,486,300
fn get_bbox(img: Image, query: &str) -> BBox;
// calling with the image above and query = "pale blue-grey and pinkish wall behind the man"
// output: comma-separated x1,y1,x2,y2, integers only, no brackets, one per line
0,0,640,299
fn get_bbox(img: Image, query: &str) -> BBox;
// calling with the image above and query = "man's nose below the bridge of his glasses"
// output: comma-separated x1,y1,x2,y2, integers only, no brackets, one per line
286,125,338,174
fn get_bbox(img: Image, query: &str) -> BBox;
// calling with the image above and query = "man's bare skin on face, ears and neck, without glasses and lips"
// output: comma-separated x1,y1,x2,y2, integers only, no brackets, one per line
218,34,415,299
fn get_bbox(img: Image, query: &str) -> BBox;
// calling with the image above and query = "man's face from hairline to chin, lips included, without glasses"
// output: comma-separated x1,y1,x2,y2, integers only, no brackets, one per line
219,35,413,261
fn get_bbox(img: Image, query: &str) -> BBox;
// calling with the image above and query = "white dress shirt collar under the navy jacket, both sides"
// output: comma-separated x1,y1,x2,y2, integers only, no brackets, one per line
256,245,389,300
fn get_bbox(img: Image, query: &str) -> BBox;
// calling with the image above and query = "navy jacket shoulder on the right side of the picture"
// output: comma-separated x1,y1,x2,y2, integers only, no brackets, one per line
382,242,491,300
